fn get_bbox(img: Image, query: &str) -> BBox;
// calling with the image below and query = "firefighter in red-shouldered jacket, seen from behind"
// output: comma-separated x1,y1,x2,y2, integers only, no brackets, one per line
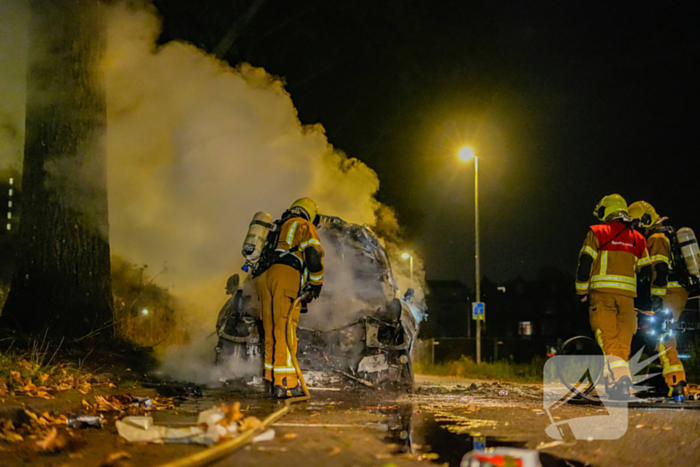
576,194,650,400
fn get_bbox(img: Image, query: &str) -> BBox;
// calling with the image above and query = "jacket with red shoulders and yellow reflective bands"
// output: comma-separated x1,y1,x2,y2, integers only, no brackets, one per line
576,221,651,297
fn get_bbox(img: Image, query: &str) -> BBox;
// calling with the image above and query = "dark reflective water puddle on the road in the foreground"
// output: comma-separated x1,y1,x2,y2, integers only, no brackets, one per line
381,403,587,467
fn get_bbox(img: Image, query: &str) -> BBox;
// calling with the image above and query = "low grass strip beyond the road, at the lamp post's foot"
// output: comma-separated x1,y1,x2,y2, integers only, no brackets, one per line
414,355,546,383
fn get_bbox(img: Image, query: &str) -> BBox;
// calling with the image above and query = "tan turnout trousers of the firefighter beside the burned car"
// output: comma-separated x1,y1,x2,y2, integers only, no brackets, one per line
258,264,301,388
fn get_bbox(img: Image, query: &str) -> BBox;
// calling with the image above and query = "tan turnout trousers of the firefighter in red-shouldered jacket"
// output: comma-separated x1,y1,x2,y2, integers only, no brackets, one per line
589,290,637,383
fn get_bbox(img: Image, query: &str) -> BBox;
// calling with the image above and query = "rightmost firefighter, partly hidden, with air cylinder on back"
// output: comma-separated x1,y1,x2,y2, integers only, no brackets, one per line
629,201,688,398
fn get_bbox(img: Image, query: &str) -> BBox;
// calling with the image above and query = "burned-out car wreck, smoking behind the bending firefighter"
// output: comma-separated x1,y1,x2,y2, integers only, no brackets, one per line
216,216,418,389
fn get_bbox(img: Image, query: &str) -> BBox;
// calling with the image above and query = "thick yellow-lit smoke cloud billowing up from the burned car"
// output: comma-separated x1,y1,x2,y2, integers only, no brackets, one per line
0,0,422,382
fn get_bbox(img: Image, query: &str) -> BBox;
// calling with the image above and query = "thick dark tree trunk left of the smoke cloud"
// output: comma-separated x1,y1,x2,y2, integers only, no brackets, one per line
3,0,112,337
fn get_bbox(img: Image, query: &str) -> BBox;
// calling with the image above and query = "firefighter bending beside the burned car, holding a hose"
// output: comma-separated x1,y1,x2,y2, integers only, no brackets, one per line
257,198,324,399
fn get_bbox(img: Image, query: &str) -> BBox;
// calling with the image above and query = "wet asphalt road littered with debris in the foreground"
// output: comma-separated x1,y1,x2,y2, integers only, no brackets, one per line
0,376,700,467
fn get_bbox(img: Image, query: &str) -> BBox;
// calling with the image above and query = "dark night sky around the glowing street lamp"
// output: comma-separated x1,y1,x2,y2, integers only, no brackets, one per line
155,0,700,288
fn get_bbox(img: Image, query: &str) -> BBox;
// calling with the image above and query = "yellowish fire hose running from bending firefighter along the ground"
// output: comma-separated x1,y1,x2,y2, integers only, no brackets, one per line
159,294,311,467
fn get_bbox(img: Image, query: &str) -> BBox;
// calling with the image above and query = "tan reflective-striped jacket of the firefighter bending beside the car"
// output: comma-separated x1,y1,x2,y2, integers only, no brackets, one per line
275,217,325,287
